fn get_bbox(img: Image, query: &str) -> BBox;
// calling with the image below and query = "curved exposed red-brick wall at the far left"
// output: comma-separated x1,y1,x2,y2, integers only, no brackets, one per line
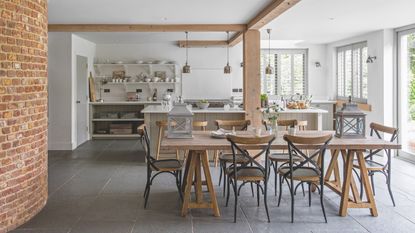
0,0,48,232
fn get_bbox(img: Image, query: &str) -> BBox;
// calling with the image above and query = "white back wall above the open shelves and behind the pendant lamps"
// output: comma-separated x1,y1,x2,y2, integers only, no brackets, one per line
96,43,243,98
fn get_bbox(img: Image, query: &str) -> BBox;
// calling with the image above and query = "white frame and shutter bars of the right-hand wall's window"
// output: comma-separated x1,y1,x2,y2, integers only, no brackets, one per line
335,41,369,104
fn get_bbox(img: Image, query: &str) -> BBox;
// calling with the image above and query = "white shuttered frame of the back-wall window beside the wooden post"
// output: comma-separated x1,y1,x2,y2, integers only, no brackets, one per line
261,48,309,97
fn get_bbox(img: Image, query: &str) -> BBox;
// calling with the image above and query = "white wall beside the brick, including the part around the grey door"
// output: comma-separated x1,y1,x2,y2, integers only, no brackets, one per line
48,32,95,150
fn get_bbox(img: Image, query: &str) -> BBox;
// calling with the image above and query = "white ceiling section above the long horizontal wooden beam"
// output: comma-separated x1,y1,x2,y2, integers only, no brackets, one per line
49,0,272,24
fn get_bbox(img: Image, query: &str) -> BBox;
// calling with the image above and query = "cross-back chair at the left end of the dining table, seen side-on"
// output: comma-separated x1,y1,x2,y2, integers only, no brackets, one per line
137,124,183,208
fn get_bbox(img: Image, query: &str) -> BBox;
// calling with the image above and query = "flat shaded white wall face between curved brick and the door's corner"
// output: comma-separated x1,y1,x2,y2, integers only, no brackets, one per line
48,32,72,150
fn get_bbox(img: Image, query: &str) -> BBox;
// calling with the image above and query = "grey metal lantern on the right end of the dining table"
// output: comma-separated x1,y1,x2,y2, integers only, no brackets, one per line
335,97,366,138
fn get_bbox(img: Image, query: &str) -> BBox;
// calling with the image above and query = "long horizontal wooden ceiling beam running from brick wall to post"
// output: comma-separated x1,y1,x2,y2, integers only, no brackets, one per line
48,24,246,32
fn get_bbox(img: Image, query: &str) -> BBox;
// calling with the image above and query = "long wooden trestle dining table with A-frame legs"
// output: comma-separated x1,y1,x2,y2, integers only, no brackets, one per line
161,131,401,216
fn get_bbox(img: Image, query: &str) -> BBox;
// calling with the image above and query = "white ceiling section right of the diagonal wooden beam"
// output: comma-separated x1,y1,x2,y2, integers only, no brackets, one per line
261,0,415,44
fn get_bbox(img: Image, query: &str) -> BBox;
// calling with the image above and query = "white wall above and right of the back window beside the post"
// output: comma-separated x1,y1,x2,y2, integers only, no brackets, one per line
261,40,329,100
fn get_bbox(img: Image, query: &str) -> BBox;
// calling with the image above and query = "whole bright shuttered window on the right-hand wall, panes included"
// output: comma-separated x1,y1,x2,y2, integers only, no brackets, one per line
337,42,367,103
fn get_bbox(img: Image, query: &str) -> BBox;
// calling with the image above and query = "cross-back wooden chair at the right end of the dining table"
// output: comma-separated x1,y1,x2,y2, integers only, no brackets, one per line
353,123,398,206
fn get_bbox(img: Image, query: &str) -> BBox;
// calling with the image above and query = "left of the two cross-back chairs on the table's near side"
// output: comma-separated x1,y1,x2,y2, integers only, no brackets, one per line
226,135,275,222
